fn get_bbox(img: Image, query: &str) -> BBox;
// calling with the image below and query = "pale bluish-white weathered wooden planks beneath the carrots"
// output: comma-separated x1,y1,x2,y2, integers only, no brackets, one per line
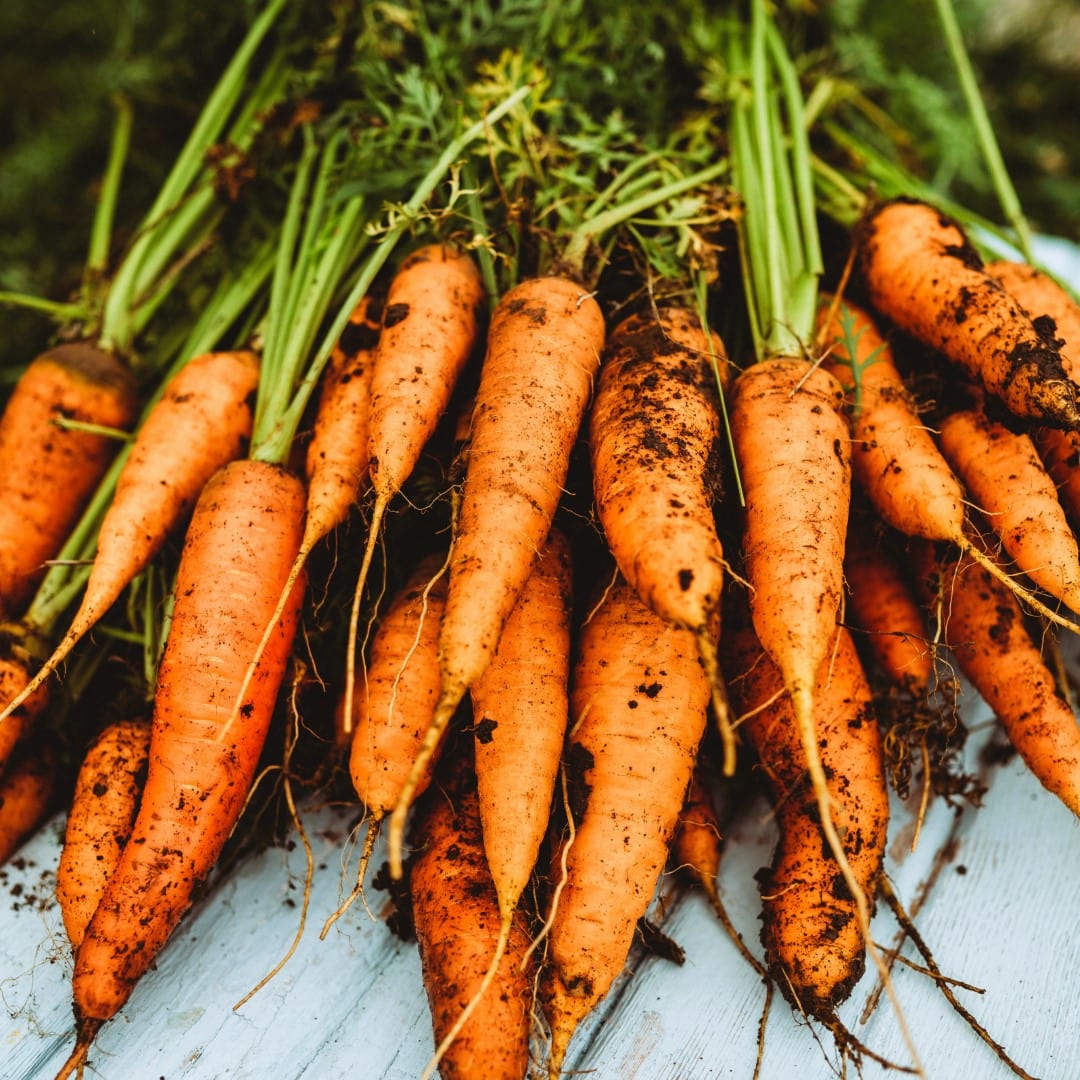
0,686,1080,1080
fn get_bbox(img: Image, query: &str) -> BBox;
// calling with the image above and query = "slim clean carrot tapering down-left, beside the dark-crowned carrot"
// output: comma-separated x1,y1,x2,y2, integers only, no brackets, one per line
0,352,259,724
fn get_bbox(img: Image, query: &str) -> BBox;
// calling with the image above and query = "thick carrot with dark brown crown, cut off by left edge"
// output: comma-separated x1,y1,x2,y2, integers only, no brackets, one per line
0,343,136,619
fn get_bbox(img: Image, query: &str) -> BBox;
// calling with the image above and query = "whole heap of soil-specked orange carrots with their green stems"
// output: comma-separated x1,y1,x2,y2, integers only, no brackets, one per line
0,0,1080,1077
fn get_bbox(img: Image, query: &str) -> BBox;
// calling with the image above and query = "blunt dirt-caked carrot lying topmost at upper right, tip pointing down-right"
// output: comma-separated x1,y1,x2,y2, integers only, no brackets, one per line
856,199,1080,430
